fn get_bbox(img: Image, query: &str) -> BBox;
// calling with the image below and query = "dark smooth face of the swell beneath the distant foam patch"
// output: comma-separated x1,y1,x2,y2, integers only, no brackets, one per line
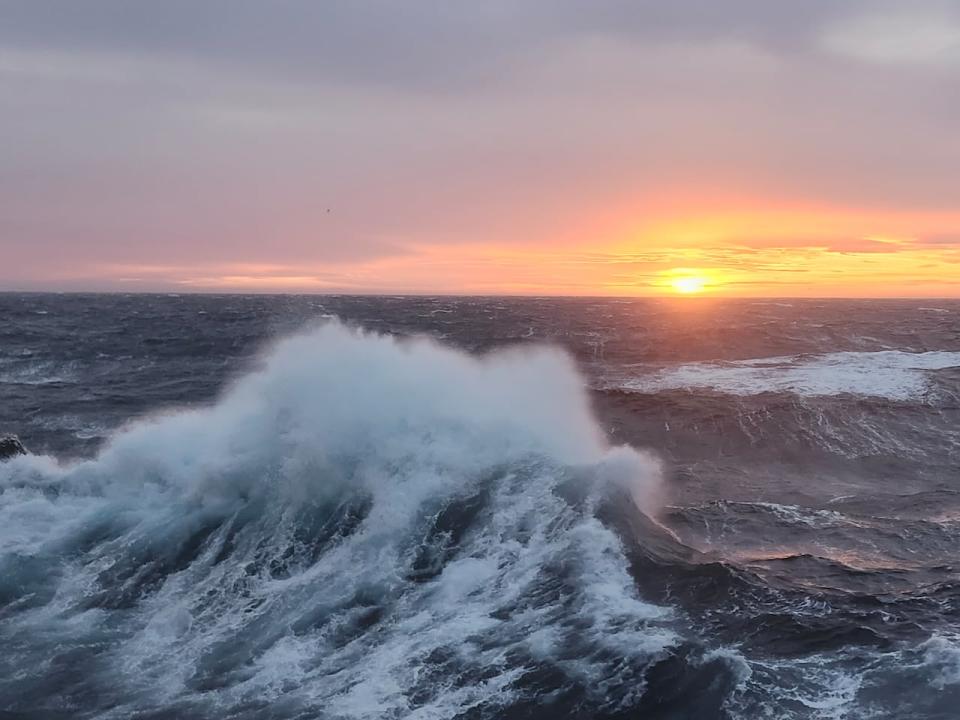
595,385,960,486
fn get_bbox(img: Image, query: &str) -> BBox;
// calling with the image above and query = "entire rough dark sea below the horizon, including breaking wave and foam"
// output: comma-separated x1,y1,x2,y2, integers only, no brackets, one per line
0,294,960,720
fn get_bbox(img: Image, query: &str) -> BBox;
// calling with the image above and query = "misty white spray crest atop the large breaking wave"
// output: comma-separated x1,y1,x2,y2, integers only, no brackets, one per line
39,323,632,500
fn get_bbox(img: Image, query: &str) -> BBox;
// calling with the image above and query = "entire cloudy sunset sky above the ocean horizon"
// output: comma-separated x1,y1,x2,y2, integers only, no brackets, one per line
0,0,960,297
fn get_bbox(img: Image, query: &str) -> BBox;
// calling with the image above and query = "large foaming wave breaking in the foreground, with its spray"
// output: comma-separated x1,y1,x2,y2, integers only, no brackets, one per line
0,323,678,718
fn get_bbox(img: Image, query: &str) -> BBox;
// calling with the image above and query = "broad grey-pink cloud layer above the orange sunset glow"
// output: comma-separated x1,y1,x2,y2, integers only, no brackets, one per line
0,0,960,292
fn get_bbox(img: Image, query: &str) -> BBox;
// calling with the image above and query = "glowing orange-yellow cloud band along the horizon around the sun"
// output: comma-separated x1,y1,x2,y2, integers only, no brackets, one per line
16,197,960,296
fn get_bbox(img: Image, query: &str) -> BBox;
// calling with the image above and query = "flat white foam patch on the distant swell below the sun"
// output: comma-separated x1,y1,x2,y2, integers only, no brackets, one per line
622,350,960,400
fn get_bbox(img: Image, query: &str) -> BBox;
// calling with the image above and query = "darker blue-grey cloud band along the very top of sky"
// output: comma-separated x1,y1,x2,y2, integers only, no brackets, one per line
0,0,888,91
